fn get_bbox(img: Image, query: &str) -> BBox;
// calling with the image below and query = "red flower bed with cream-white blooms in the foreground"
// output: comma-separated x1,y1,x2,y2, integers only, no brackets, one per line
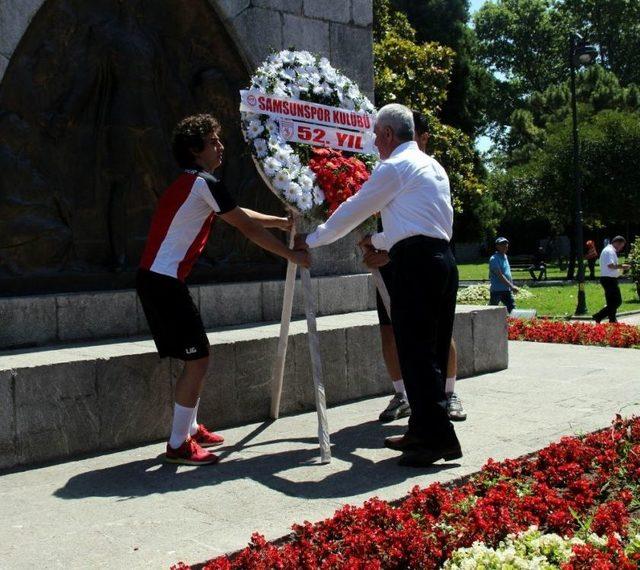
172,417,640,570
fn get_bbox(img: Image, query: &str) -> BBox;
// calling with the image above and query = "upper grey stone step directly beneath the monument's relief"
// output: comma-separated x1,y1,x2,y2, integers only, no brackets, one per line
0,273,375,350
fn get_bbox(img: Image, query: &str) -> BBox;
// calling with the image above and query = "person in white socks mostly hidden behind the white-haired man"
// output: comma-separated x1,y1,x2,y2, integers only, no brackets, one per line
363,111,467,422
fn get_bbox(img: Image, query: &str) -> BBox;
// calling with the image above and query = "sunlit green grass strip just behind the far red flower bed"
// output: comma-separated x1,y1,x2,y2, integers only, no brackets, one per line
516,283,640,317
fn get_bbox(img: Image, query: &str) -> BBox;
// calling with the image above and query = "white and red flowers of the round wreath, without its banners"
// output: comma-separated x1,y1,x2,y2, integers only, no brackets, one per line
241,50,378,221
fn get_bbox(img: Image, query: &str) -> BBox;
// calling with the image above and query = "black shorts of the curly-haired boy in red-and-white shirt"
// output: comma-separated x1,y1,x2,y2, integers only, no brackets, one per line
136,269,209,360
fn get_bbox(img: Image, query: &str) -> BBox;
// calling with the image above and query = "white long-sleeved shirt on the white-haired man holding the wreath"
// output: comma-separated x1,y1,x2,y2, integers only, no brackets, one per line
307,141,453,251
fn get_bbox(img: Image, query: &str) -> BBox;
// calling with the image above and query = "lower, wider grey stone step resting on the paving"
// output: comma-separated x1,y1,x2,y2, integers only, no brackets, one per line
0,306,507,468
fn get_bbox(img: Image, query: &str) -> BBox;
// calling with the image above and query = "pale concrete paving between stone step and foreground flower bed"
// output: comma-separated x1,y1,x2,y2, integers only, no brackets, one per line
0,342,640,569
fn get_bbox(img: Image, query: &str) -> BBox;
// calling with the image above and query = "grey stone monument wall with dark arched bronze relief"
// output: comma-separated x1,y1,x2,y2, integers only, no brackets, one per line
0,0,372,294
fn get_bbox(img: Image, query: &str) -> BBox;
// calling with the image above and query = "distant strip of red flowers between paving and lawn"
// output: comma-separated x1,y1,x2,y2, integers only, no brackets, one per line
509,318,640,348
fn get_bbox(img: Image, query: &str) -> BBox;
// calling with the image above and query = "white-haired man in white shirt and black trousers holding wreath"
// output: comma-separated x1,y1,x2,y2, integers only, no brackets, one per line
296,104,462,467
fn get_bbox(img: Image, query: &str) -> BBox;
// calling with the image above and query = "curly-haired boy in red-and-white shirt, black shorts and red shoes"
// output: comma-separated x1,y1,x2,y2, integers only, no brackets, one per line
136,114,309,465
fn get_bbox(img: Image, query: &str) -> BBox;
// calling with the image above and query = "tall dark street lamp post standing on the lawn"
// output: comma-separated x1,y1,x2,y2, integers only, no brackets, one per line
569,33,598,315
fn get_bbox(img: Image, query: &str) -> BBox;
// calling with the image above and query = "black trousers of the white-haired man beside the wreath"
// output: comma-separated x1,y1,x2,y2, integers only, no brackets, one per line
390,236,458,449
